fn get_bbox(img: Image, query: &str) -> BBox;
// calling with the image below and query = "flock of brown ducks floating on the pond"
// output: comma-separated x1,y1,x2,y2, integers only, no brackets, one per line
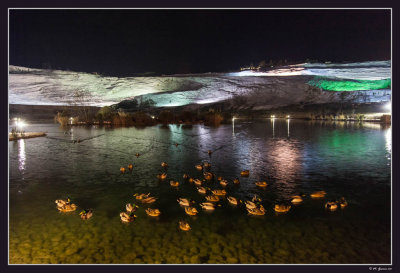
55,151,348,231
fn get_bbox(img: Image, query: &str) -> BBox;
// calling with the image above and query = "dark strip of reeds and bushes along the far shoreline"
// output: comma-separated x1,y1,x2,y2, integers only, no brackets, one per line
55,98,383,126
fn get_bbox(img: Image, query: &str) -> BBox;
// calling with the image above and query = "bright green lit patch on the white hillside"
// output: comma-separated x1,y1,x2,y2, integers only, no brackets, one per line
308,78,391,91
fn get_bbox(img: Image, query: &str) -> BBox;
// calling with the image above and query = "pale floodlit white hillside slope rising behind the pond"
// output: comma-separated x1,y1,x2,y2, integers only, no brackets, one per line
9,61,391,109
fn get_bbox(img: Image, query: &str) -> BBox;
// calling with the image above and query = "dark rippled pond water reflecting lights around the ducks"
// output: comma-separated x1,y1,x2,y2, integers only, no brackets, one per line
9,119,391,264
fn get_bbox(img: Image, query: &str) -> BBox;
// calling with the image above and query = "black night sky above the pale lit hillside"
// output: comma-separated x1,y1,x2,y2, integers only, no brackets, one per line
10,9,391,76
